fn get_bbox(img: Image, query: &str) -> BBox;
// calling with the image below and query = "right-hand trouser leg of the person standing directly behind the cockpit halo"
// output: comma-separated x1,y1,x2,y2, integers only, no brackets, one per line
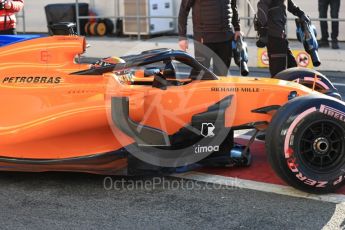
213,40,232,76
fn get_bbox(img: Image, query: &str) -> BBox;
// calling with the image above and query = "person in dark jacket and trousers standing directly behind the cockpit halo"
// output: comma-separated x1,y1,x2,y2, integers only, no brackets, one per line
178,0,241,76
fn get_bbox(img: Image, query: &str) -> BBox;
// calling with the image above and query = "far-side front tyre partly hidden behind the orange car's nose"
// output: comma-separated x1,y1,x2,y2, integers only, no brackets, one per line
274,67,342,100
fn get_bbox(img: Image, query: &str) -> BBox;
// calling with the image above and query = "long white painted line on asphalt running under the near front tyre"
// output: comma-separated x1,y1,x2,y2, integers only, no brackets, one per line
174,172,345,204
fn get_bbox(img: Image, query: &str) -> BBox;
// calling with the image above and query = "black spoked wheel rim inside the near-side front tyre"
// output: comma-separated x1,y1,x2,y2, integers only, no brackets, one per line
298,120,345,173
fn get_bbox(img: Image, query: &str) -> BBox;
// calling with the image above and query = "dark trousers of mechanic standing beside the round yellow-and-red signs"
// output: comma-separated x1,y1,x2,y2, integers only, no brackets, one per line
267,36,297,77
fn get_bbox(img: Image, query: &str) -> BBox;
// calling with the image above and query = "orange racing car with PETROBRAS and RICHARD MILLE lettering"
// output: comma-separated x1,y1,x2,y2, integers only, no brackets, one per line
0,35,345,193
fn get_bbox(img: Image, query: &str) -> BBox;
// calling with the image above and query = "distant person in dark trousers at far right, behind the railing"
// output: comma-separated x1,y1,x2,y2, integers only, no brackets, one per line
319,0,340,49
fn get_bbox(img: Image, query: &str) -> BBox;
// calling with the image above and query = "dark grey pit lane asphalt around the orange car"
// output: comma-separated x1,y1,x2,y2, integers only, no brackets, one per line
0,70,345,229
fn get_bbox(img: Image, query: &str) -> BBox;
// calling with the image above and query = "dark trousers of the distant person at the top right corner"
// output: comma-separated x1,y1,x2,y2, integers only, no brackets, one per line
319,0,340,40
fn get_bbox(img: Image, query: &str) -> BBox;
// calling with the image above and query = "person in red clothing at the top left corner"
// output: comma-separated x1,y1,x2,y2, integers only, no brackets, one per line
0,0,24,35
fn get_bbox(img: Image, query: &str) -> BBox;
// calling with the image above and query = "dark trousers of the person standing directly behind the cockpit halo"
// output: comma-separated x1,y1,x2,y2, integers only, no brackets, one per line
194,39,232,76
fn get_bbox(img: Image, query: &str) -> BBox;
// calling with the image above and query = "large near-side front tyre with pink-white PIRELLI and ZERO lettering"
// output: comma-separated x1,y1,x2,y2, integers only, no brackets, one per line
266,95,345,193
